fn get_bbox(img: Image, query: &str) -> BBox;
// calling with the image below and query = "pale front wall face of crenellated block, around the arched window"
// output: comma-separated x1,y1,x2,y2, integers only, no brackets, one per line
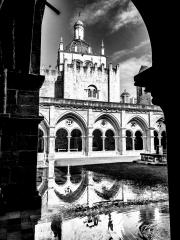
64,61,108,102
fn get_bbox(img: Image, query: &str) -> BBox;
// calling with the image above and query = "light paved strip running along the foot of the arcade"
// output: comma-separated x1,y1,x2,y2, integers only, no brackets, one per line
55,156,141,166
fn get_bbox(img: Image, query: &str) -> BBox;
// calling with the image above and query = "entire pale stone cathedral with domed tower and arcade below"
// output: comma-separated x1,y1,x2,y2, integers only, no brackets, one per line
38,20,166,163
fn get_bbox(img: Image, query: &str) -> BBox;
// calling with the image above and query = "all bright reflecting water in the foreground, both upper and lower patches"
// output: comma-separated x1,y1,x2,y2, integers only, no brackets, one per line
35,166,170,240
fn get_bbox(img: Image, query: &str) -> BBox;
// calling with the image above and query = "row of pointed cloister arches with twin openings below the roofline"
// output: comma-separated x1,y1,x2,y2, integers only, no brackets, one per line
38,111,166,162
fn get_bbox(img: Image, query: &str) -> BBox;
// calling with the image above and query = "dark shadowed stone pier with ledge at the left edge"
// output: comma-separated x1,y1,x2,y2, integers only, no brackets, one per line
0,72,44,209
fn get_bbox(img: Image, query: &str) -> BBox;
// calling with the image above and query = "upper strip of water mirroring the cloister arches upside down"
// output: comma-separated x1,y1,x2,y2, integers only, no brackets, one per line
38,166,166,209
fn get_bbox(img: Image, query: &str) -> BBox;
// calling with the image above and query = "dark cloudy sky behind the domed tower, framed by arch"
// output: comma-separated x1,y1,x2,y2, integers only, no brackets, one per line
41,0,151,97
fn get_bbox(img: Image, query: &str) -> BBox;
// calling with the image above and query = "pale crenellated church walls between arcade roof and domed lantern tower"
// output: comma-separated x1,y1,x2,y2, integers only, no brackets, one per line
40,58,120,102
